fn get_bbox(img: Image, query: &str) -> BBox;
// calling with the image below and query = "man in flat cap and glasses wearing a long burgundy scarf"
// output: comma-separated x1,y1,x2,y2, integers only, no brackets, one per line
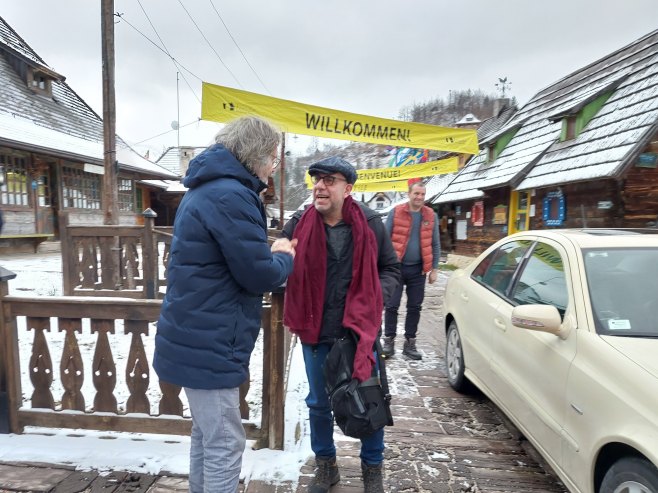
283,156,400,493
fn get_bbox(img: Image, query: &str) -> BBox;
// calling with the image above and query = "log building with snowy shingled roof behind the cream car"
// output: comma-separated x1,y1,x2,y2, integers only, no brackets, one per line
432,30,658,256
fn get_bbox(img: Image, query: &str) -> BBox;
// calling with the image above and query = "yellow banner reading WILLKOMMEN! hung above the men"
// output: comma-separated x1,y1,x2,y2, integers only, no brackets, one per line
201,82,479,154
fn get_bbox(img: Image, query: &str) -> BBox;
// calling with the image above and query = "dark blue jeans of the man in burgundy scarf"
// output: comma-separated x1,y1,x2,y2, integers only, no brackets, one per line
302,344,384,465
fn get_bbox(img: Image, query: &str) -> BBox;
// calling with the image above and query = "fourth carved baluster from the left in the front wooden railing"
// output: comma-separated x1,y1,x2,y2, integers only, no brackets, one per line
123,320,151,414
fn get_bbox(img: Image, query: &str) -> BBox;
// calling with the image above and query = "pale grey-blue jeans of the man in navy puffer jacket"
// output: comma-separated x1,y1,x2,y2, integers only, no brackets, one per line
185,387,246,493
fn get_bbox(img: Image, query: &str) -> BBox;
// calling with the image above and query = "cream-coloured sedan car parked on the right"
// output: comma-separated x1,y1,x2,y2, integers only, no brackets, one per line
444,229,658,493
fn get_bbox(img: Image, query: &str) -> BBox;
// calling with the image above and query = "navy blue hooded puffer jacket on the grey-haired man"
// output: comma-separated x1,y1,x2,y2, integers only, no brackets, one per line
153,145,293,389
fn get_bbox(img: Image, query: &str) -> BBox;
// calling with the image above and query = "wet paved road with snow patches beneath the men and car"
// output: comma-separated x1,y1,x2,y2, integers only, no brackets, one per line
0,270,566,493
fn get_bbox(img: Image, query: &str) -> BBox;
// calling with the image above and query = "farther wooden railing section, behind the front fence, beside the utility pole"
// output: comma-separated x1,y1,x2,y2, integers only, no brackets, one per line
60,209,173,299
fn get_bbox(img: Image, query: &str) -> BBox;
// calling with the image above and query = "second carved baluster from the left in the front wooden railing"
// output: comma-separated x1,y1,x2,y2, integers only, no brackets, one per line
58,318,85,411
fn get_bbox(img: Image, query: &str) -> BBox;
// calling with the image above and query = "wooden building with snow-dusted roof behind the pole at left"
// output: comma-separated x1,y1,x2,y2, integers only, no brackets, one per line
0,13,178,250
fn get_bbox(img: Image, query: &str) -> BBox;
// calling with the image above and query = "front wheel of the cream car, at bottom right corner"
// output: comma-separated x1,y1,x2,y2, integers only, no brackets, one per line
599,457,658,493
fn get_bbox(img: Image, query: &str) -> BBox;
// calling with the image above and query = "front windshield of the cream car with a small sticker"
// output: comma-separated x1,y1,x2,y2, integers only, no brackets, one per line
583,248,658,337
